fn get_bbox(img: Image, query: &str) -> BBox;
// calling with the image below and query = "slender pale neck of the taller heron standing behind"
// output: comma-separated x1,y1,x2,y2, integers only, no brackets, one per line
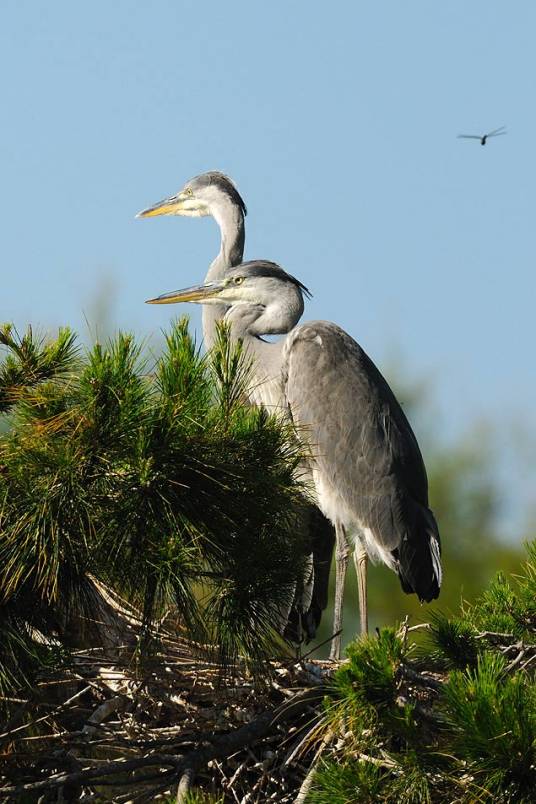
202,202,246,349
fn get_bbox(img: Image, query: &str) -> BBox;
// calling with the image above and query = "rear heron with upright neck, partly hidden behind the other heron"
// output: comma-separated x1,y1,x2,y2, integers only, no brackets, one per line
136,170,335,641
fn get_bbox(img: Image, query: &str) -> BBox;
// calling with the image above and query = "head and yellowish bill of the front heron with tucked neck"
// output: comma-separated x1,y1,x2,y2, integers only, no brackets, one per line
147,260,311,334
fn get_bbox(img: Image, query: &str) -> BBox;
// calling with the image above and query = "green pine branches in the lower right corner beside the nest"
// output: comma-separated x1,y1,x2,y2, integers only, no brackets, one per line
307,542,536,804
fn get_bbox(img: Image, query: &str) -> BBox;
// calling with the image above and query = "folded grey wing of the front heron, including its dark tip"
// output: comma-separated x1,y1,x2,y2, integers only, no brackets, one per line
284,321,441,599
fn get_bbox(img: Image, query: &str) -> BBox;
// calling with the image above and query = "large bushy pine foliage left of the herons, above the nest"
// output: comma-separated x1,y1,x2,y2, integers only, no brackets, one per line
0,319,310,690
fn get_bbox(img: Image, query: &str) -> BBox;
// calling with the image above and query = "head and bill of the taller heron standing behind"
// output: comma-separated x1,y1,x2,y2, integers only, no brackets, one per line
136,170,247,218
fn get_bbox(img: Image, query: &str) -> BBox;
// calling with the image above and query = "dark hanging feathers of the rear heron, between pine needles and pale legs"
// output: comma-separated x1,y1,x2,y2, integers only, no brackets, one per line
284,505,335,642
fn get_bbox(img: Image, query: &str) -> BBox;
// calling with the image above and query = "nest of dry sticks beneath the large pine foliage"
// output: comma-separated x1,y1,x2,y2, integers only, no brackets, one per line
0,588,333,804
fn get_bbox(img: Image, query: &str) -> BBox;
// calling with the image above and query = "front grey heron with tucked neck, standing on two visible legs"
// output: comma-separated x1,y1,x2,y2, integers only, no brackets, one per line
148,261,442,659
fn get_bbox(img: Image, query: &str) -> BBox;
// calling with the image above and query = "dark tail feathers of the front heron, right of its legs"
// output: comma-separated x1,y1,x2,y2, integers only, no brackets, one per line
396,503,442,603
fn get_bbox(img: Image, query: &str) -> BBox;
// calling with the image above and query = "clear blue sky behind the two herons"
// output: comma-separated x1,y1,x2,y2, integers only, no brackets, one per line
0,0,536,528
